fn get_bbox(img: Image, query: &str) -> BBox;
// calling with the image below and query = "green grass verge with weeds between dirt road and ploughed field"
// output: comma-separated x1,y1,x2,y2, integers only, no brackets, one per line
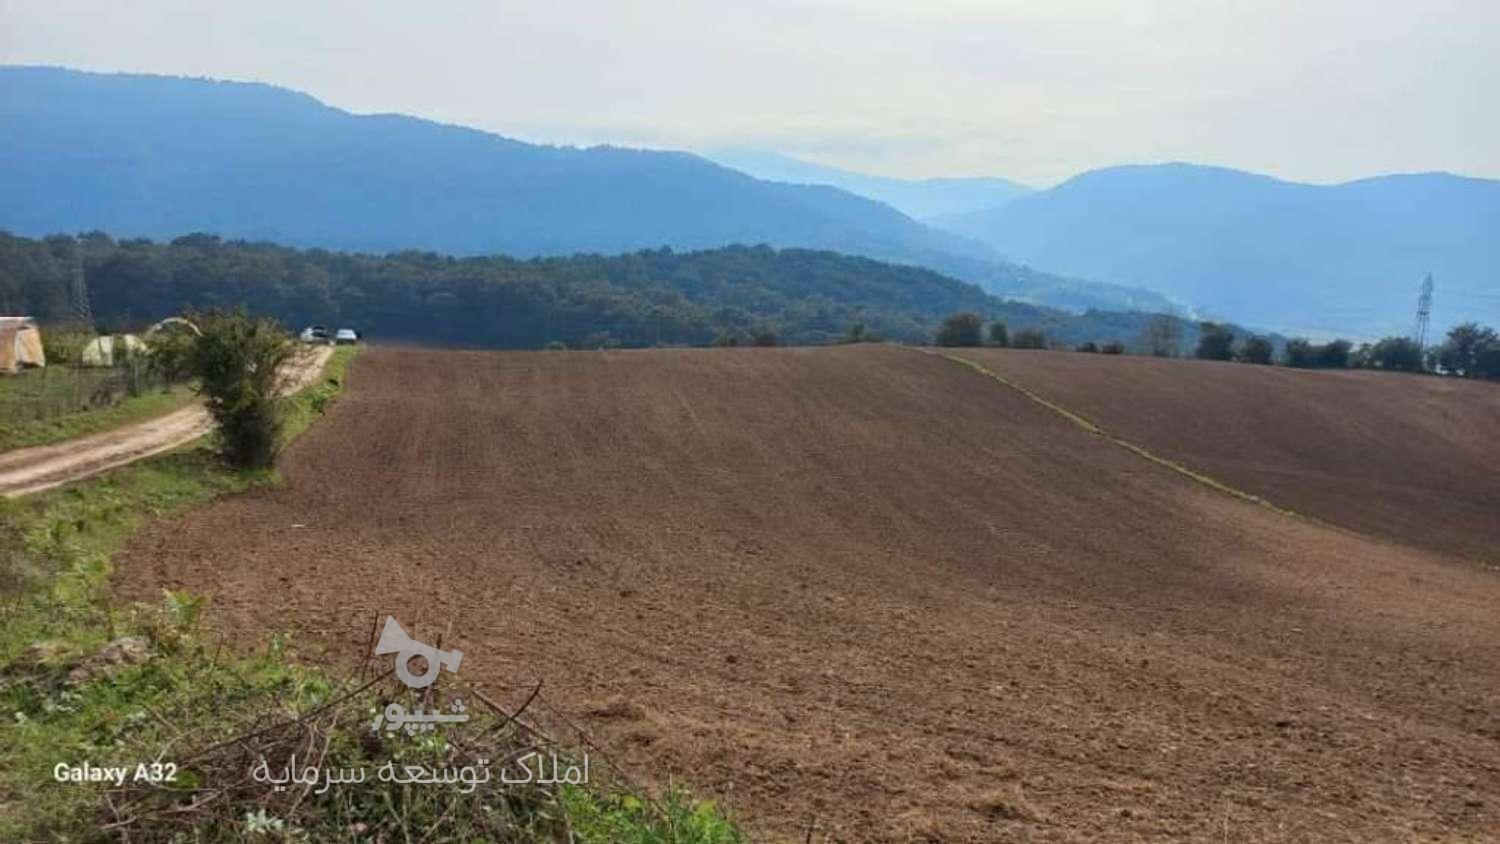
0,349,744,844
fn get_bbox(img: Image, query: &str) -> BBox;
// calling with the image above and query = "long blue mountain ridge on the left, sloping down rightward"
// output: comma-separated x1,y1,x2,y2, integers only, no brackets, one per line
0,67,1164,309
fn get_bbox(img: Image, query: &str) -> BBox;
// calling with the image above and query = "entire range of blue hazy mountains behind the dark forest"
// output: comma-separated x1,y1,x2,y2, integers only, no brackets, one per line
0,67,1500,337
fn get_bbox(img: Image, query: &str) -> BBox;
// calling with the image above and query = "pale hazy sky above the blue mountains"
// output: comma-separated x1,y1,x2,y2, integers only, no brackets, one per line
0,0,1500,184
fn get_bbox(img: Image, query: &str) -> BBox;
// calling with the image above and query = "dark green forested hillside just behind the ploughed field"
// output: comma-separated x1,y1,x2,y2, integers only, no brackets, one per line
0,232,1193,348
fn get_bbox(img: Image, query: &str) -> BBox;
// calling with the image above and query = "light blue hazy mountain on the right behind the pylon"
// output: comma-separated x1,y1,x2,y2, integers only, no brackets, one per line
936,163,1500,336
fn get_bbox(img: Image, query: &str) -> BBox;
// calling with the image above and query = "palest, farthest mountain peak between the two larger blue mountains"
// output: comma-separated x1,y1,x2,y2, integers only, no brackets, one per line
707,147,1031,220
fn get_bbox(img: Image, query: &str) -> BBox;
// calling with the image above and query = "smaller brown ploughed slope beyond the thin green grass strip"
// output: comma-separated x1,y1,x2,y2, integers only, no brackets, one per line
962,349,1500,565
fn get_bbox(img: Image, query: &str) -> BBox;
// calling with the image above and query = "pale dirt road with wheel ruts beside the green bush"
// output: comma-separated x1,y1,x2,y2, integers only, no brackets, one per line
0,346,333,498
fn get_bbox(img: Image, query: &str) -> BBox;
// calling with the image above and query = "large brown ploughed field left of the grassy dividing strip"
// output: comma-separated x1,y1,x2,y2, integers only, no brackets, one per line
119,346,1500,843
